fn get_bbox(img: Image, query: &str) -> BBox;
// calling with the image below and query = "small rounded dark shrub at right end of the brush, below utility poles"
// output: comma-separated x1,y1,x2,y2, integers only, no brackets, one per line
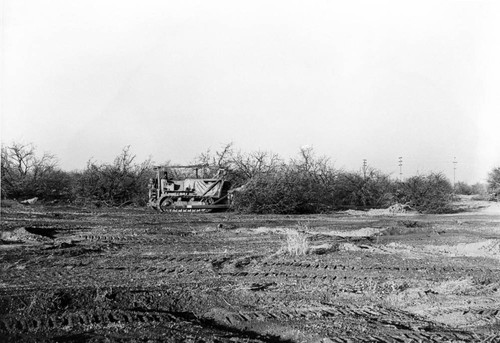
395,173,453,213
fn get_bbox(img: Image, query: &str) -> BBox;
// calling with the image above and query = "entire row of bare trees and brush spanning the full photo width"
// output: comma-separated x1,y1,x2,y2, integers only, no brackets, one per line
1,143,500,214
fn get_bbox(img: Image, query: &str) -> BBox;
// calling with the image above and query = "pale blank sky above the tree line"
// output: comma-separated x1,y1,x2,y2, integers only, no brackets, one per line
1,0,500,183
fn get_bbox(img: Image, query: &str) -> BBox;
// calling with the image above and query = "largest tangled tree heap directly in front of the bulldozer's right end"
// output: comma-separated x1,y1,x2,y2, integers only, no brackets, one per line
234,148,394,214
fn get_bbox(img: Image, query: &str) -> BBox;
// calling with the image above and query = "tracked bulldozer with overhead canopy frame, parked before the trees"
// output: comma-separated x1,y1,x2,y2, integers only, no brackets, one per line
148,165,231,212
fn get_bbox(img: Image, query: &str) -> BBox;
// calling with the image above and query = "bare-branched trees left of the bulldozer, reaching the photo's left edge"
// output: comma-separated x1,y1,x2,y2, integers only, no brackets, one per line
1,143,151,206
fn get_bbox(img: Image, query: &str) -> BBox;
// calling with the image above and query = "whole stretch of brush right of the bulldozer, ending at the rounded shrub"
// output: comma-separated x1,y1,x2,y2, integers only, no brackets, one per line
197,145,453,214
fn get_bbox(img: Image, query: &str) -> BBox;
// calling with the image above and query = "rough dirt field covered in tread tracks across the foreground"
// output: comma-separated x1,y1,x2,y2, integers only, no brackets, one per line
0,202,500,342
